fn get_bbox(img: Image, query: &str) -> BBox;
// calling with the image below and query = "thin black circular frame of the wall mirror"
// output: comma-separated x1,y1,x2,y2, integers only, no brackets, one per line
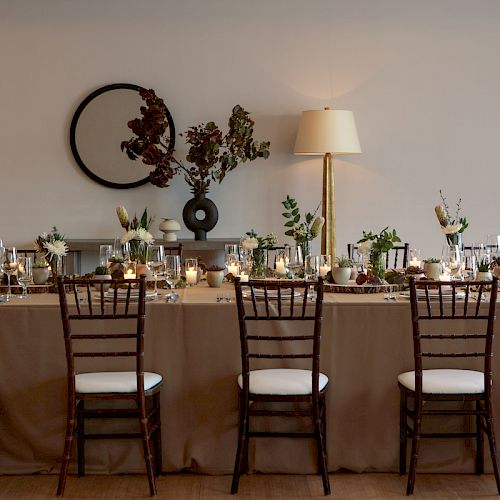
69,83,175,189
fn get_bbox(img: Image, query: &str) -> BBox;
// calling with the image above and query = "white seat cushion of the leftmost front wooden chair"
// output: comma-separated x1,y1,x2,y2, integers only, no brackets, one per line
75,372,162,394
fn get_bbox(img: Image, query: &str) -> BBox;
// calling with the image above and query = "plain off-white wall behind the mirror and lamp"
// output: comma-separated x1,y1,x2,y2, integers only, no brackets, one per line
0,0,500,255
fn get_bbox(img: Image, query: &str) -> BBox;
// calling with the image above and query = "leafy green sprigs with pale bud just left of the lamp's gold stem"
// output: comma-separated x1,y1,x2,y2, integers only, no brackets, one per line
281,194,325,259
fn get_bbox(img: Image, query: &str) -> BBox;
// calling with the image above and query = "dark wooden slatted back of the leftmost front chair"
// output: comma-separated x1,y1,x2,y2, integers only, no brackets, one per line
57,276,146,399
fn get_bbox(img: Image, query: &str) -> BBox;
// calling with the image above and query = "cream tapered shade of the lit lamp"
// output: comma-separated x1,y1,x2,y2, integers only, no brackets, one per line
293,109,361,155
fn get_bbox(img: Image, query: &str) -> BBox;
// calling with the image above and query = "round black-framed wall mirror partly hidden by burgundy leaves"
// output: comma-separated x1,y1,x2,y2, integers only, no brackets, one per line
70,83,175,189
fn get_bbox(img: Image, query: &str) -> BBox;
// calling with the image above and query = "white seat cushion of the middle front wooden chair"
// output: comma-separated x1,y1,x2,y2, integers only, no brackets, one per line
238,368,328,396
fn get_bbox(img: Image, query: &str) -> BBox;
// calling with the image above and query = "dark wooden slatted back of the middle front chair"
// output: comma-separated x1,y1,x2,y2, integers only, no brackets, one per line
235,278,323,397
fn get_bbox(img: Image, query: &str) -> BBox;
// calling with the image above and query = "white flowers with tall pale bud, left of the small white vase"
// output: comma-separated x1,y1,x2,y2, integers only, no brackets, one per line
116,207,153,264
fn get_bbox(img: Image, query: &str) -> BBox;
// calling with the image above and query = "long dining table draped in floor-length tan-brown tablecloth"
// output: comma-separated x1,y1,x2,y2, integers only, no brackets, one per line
0,283,500,474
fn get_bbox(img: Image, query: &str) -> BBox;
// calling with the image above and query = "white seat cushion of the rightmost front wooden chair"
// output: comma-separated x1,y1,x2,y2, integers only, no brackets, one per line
398,369,484,394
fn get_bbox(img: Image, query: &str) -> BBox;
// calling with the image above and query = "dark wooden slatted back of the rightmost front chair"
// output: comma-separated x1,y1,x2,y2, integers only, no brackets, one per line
410,278,498,393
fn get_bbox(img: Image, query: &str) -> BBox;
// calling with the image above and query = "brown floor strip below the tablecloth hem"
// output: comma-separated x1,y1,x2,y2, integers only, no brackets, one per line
0,473,498,500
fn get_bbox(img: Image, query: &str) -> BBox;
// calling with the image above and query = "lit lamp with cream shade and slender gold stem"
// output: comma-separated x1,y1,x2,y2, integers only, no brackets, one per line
294,108,361,259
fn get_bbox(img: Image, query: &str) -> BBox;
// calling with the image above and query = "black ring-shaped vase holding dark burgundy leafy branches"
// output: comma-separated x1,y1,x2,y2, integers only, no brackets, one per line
121,89,270,240
